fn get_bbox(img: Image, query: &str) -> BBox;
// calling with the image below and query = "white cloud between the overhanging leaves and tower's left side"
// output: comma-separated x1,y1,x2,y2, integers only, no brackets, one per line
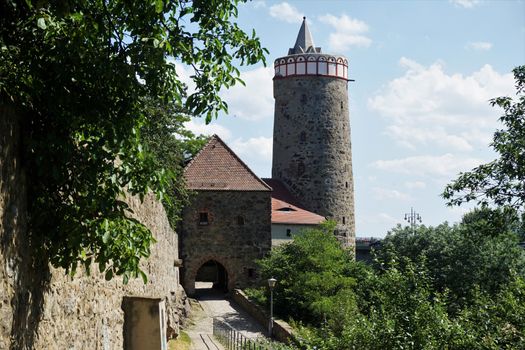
221,67,274,120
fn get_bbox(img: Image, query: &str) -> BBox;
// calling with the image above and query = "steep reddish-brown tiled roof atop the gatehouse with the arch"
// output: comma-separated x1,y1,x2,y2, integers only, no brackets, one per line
184,135,271,191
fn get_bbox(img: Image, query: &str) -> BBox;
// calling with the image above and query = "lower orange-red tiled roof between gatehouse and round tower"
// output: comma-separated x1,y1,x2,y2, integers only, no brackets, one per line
263,179,326,225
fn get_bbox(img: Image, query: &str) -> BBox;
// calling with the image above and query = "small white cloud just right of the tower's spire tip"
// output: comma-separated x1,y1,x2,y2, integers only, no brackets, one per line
319,14,372,52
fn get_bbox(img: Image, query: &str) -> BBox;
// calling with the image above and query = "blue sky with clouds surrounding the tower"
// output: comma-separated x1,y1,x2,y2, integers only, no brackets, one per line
179,0,525,237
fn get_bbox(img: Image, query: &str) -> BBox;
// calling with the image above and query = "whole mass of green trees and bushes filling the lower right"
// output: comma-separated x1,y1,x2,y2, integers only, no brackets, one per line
252,212,525,350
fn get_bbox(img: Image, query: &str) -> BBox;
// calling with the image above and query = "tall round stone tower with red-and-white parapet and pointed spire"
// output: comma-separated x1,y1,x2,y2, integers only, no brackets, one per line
272,18,355,246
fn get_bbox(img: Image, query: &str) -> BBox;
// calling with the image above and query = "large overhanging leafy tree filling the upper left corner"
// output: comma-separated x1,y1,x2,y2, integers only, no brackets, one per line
0,0,265,282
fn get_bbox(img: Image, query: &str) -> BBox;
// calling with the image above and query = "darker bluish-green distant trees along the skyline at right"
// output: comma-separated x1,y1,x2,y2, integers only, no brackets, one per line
376,208,525,313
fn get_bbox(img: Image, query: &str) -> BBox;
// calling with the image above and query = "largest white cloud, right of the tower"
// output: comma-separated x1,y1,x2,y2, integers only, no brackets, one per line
368,57,514,152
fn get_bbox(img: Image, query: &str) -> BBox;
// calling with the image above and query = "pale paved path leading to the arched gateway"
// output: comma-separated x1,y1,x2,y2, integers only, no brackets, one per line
185,282,264,350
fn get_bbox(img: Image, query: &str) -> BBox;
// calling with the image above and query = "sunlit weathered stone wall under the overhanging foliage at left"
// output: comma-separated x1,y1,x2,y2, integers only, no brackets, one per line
0,108,188,350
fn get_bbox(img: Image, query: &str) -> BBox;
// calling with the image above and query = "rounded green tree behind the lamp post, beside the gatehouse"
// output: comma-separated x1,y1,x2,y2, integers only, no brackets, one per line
253,222,355,325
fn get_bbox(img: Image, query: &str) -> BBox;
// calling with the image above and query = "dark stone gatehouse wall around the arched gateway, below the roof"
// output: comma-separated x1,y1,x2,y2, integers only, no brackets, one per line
180,191,271,295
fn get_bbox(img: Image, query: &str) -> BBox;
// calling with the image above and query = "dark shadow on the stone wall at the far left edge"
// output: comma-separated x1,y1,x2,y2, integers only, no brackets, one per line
0,105,50,349
